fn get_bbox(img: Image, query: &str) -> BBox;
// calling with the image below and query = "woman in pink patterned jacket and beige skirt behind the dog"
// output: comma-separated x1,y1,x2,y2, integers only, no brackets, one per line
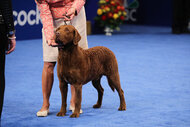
36,0,88,116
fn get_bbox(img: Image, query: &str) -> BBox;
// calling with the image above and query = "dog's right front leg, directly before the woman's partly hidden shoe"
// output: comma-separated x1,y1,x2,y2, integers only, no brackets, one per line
70,84,82,118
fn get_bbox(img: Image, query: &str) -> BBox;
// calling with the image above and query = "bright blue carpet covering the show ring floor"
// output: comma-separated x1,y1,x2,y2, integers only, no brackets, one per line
1,25,190,127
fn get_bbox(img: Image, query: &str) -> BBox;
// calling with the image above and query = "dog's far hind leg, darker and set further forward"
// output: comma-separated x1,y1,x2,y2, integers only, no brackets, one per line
92,77,104,108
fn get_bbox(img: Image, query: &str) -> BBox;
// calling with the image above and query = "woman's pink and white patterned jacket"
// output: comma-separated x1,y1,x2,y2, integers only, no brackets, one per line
35,0,85,40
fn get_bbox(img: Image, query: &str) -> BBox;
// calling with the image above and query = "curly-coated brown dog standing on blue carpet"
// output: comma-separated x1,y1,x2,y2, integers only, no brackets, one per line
56,25,126,117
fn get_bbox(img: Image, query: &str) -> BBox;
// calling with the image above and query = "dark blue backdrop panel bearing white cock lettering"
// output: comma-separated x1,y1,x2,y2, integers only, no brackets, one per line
12,0,42,40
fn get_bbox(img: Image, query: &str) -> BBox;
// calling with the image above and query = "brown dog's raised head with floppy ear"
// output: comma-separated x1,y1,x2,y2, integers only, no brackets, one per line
55,25,81,46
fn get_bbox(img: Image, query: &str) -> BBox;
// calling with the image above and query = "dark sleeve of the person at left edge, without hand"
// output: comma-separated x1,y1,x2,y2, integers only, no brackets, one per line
0,0,15,32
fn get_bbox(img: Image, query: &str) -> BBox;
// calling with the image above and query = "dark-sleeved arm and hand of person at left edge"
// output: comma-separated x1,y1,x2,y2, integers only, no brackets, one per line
0,0,16,54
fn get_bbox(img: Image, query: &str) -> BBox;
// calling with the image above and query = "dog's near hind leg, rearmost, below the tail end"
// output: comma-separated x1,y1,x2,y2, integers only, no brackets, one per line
107,72,126,111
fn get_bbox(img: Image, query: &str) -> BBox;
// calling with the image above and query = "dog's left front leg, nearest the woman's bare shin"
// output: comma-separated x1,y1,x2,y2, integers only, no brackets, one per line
57,80,68,116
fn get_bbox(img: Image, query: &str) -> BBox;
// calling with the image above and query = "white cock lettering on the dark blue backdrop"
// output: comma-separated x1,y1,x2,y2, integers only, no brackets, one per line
13,6,41,26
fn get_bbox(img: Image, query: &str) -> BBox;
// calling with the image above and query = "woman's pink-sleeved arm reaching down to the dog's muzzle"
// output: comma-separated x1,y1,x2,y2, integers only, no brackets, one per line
35,0,54,45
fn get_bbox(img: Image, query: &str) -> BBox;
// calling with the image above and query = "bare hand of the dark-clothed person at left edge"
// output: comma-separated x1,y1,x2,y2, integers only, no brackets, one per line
6,35,16,54
